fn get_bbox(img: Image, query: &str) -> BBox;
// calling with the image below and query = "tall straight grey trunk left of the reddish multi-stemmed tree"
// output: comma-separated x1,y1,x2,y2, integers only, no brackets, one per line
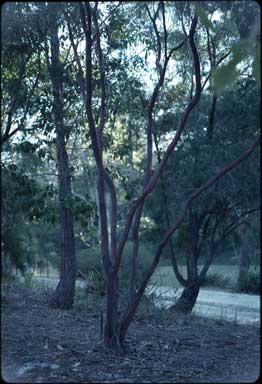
48,3,76,309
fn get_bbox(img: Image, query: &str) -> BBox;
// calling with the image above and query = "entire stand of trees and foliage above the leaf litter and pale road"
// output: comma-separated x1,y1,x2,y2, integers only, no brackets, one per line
1,1,261,352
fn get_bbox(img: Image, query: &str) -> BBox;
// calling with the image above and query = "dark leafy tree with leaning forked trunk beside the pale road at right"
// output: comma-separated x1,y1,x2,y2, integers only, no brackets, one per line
146,2,258,312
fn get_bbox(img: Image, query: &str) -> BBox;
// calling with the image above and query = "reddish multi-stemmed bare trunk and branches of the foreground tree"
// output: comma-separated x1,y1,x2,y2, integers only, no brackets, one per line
68,3,257,353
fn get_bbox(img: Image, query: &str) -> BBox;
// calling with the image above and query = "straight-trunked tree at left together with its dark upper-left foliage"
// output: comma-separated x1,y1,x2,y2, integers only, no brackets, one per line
1,3,80,309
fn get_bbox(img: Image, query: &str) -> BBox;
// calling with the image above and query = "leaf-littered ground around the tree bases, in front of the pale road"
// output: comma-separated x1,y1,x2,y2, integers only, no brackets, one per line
1,286,260,383
